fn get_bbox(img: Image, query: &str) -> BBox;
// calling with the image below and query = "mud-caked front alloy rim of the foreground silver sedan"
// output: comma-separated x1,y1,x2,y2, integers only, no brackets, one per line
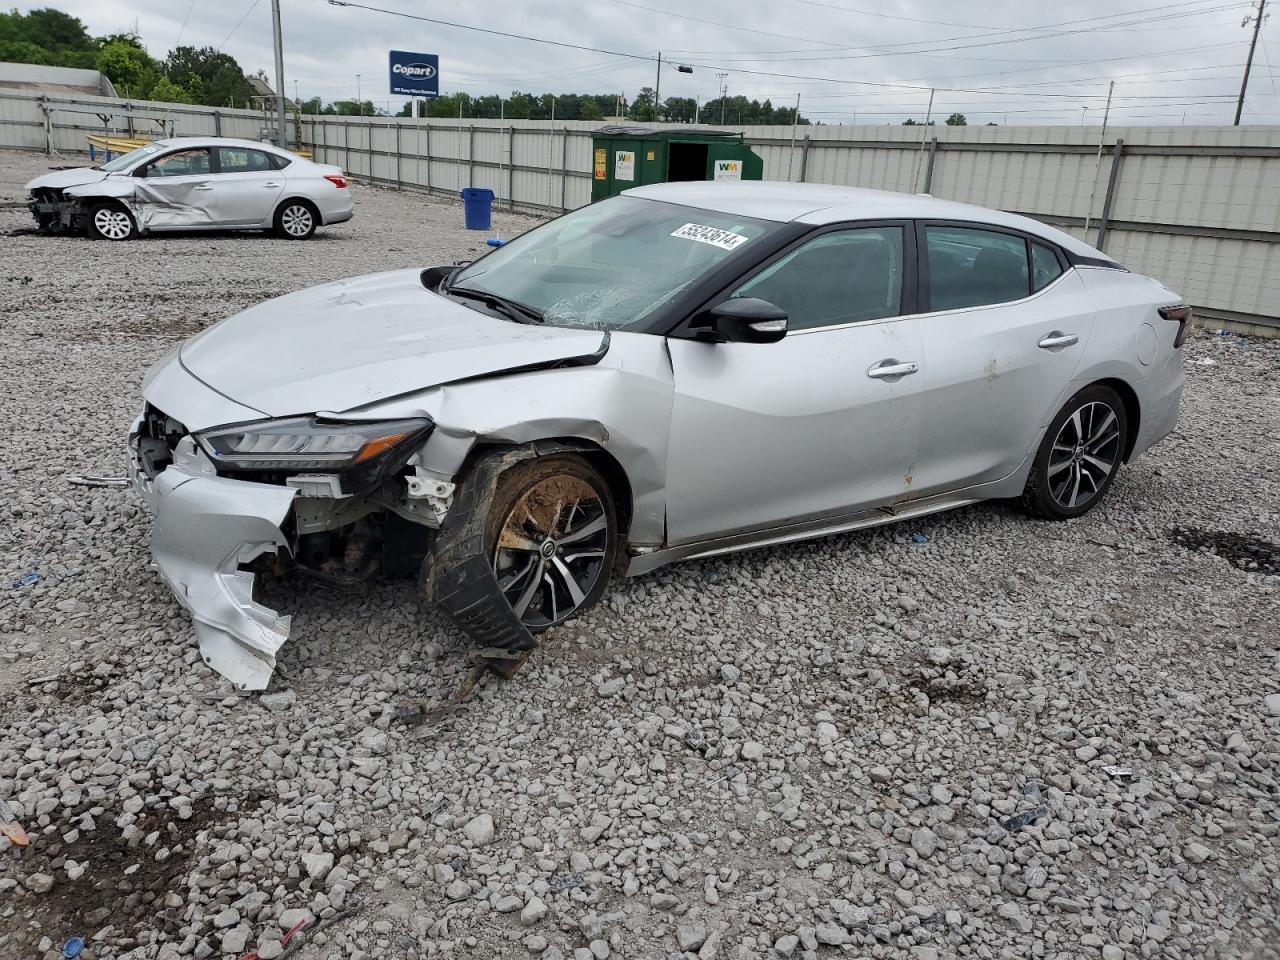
493,475,612,630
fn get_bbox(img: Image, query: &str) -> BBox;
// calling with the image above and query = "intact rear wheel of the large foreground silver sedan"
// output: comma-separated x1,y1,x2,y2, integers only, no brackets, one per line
1020,385,1129,520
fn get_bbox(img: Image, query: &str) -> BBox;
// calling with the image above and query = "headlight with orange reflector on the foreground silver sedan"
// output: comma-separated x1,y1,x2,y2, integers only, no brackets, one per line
196,417,431,471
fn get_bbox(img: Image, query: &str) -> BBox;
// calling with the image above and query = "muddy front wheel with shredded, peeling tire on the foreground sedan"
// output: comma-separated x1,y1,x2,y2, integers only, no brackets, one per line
424,451,618,658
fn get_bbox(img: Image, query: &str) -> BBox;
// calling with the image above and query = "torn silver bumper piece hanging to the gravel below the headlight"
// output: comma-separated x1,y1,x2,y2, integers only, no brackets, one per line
147,465,298,690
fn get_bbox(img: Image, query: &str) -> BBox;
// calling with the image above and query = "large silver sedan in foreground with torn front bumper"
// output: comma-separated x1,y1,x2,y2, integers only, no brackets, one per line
129,183,1190,690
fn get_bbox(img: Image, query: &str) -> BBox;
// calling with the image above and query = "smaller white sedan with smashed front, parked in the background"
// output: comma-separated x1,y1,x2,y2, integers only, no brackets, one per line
27,137,352,241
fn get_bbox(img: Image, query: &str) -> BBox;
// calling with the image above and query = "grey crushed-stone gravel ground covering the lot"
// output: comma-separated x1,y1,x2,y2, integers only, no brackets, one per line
0,144,1280,960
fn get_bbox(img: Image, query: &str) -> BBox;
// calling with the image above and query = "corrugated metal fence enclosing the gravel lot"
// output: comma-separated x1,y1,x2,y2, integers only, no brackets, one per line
0,91,1280,328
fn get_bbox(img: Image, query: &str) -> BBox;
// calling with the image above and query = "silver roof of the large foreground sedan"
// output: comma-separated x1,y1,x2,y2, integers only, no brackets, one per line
623,180,1105,257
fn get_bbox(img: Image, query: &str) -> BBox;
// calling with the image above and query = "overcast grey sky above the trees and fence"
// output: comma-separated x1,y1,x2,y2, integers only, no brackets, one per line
22,0,1280,124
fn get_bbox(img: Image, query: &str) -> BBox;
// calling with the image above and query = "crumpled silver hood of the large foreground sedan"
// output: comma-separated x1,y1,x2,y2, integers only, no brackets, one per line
179,270,607,417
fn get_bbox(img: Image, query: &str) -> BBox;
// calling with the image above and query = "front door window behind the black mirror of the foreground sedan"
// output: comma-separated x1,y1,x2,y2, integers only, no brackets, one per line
732,227,902,330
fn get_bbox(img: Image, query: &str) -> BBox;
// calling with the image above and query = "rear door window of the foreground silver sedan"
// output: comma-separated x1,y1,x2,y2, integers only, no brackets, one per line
924,227,1030,310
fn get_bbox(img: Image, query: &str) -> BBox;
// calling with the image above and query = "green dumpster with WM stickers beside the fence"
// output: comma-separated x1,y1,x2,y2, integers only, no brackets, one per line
591,125,764,202
